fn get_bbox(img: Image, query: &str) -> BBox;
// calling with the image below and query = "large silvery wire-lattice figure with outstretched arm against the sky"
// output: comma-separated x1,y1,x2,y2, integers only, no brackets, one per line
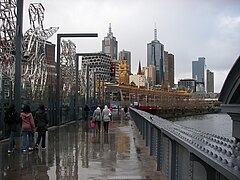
22,3,58,99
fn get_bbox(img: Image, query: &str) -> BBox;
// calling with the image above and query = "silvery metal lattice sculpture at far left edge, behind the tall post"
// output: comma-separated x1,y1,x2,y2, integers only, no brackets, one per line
0,0,17,81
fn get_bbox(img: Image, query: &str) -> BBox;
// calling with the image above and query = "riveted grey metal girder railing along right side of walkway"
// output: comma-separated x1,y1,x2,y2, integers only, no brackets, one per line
130,108,240,180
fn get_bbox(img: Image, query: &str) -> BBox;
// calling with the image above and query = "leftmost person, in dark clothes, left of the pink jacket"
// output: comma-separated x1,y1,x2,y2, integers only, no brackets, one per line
4,104,19,153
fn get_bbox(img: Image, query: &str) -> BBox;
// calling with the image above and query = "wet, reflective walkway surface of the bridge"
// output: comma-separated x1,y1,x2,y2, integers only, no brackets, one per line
0,111,164,180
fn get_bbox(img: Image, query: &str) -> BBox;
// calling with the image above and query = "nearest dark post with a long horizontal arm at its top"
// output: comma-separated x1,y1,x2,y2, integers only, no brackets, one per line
54,33,98,125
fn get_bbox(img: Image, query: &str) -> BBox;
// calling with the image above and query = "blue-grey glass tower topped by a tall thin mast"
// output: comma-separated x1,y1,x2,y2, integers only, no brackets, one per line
147,25,165,84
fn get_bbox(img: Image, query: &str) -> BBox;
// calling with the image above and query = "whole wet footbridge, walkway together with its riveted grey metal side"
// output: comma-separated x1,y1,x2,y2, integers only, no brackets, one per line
0,108,240,180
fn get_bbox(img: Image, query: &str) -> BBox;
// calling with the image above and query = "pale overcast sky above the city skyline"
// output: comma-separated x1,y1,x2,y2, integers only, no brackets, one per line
24,0,240,92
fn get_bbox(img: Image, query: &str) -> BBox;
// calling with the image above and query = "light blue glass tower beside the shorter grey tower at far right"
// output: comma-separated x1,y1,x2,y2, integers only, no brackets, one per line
192,57,206,91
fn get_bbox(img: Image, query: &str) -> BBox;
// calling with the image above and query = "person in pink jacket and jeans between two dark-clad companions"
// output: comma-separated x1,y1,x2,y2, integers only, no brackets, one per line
20,105,35,152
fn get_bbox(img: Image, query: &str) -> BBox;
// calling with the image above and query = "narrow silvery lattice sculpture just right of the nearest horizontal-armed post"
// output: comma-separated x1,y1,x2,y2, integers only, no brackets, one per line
60,40,76,105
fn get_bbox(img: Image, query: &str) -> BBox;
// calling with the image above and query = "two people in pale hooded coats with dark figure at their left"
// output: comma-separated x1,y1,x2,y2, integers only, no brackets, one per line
84,105,112,134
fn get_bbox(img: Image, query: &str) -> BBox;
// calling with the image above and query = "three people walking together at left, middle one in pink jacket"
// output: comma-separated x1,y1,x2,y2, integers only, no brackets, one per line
4,104,48,153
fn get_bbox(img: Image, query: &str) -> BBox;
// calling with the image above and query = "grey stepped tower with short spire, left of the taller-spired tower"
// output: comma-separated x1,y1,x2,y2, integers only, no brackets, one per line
102,23,118,60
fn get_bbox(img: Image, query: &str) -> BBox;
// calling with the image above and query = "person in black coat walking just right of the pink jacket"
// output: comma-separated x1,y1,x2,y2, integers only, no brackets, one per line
34,104,48,150
